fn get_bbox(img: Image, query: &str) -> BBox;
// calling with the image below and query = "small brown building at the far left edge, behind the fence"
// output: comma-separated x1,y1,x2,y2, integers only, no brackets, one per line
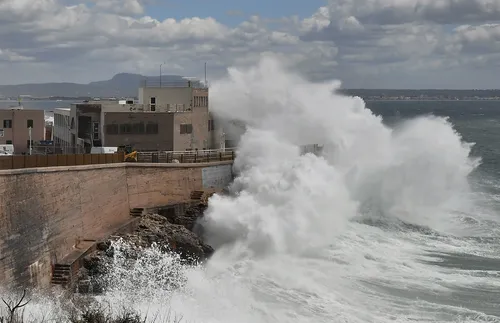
0,108,45,154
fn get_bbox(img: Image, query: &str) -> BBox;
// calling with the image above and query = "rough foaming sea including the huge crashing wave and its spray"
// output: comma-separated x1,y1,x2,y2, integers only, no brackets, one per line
2,61,500,323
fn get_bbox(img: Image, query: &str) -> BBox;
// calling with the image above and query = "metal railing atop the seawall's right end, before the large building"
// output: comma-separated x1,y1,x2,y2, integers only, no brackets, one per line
137,149,235,163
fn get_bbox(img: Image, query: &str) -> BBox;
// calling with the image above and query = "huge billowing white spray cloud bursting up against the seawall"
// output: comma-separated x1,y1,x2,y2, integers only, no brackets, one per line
201,58,475,254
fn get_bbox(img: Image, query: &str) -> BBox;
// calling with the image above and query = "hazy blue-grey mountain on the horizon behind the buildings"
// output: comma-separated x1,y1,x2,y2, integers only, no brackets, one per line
0,73,192,97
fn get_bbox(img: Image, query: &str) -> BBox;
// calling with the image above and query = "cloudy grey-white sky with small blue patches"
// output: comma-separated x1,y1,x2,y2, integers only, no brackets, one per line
0,0,500,88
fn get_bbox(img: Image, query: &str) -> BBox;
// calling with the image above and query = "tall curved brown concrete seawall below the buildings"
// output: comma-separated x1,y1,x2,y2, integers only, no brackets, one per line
0,161,232,287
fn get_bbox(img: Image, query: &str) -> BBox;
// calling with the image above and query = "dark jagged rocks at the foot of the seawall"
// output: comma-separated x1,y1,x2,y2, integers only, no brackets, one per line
75,202,214,293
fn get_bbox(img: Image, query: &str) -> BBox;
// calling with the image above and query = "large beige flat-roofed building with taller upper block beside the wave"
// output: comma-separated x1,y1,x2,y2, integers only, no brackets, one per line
54,82,224,152
